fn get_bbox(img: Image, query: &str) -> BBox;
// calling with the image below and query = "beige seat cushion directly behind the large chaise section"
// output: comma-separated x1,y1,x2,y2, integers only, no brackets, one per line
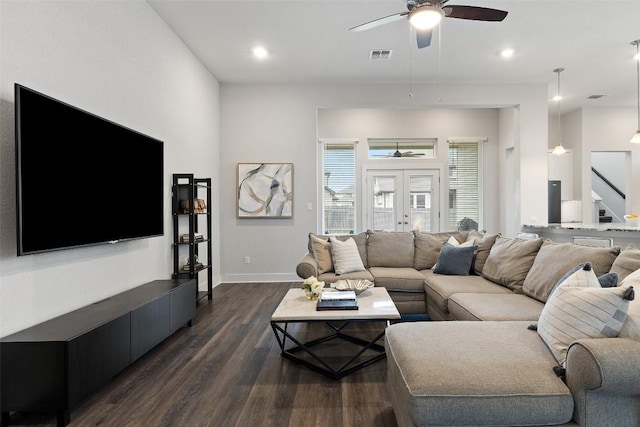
448,293,544,321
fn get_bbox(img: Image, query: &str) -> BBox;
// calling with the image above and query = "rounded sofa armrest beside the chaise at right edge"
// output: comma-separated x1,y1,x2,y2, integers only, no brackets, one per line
566,338,640,395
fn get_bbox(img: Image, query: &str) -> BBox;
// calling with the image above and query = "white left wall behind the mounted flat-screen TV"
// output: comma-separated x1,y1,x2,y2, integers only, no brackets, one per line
0,0,219,336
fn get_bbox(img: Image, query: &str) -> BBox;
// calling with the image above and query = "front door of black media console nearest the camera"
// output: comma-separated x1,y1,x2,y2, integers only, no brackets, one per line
68,313,131,408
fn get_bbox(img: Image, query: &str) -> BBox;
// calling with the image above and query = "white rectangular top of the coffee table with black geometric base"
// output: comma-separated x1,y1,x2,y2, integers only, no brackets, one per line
271,287,400,322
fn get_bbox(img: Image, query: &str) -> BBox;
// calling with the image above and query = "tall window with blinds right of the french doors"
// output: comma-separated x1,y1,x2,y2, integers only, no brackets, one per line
449,141,482,230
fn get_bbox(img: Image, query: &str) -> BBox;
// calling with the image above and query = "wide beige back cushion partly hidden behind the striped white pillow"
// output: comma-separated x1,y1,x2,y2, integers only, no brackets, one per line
522,241,620,302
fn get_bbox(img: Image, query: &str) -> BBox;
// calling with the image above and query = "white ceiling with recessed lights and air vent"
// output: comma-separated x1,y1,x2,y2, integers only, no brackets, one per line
147,0,640,112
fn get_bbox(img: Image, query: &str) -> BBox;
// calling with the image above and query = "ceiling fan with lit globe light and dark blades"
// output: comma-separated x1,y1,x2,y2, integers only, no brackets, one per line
349,0,508,49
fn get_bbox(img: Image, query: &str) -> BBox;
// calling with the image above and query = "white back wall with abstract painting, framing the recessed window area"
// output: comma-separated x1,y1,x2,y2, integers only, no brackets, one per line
220,84,548,281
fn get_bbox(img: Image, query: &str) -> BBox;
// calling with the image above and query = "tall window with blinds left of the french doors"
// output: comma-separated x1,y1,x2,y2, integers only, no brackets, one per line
322,141,356,234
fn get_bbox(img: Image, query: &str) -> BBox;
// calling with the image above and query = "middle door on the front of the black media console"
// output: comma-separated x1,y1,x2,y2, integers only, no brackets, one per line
131,294,170,362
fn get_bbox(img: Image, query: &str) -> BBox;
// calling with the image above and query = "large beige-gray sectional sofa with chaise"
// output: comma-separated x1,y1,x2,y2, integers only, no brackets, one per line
297,231,640,427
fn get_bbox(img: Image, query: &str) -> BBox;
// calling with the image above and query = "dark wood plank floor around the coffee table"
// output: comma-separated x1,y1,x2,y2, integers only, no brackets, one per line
12,283,397,427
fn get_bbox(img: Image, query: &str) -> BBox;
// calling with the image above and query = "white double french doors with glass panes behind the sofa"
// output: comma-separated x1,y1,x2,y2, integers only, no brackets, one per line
365,169,440,232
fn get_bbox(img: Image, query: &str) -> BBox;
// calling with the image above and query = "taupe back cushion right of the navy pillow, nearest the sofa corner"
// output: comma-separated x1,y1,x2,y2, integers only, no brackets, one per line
482,236,542,293
